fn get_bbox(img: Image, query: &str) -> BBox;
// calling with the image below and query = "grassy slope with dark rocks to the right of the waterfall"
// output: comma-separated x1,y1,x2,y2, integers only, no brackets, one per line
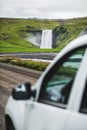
53,18,87,51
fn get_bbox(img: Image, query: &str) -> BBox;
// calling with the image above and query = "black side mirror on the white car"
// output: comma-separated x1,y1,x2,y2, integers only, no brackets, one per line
12,83,36,100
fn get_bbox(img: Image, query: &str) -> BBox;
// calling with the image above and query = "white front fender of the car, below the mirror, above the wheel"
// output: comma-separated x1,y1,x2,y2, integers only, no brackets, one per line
5,96,26,130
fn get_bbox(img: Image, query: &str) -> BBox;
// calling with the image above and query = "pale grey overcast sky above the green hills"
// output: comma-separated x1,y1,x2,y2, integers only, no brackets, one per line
0,0,87,19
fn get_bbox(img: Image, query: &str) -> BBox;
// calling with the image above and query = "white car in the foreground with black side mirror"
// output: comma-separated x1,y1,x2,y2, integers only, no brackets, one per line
5,35,87,130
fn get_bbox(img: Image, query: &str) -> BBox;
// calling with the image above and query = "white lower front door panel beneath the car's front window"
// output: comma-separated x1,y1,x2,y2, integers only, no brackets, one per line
26,101,71,130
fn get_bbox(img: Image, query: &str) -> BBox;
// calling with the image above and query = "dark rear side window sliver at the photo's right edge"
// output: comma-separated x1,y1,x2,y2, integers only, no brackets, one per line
80,81,87,114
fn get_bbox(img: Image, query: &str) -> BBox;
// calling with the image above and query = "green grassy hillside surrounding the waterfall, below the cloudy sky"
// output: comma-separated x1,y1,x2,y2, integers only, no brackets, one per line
0,18,87,53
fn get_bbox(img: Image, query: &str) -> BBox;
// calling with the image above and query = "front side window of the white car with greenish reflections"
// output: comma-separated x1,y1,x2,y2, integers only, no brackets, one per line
39,47,85,107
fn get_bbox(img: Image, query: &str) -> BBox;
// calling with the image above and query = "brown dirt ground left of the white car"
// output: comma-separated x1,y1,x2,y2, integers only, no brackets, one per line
0,65,37,130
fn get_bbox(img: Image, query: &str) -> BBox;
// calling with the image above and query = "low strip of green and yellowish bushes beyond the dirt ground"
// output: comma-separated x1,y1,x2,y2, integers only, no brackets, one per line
0,57,49,71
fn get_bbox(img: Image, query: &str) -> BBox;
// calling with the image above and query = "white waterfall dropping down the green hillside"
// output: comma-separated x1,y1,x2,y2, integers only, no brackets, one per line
40,30,52,48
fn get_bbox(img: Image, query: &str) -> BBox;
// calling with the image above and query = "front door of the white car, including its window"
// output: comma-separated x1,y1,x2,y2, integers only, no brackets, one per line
25,47,85,130
